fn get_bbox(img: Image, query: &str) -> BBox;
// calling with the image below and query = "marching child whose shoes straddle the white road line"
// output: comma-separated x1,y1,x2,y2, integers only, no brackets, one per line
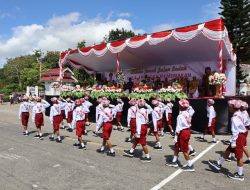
166,99,195,171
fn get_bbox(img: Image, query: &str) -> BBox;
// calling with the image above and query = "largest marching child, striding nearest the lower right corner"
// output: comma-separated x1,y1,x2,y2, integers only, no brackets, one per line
208,100,247,181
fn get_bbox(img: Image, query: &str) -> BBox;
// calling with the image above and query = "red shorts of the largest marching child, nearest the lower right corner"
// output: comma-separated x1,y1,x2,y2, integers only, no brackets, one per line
227,133,246,159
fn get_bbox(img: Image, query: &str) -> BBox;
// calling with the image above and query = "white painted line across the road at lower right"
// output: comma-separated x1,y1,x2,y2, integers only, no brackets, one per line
151,141,220,190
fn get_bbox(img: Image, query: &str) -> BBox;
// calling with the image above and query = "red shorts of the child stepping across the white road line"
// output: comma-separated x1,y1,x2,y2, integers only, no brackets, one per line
175,129,190,153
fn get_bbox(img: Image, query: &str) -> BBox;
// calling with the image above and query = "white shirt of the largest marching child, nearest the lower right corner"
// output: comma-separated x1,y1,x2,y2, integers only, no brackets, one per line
231,111,246,143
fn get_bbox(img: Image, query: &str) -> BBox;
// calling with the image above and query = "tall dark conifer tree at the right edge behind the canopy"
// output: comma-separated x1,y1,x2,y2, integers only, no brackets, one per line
220,0,250,84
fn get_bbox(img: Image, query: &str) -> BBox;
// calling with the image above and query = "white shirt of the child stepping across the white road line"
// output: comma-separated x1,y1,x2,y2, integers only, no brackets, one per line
175,110,191,134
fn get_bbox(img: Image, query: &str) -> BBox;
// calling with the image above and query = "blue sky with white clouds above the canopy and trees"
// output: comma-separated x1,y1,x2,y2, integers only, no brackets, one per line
0,0,219,67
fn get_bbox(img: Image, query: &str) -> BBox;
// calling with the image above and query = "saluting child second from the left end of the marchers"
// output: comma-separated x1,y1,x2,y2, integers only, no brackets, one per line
32,97,50,140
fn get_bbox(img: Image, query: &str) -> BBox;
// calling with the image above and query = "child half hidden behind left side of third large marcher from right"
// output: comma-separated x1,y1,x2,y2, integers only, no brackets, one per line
125,98,137,142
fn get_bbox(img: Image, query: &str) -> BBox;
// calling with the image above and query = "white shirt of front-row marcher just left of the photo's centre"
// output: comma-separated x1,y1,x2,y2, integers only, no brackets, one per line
97,107,116,130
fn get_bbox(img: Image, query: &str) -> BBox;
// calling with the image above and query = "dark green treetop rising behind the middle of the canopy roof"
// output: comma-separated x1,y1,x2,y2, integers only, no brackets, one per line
103,28,135,43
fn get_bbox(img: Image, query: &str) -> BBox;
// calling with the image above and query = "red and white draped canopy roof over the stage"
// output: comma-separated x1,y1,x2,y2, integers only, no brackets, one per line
59,19,236,95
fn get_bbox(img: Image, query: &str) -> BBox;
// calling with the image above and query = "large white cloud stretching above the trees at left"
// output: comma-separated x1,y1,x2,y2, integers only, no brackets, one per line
0,12,145,67
